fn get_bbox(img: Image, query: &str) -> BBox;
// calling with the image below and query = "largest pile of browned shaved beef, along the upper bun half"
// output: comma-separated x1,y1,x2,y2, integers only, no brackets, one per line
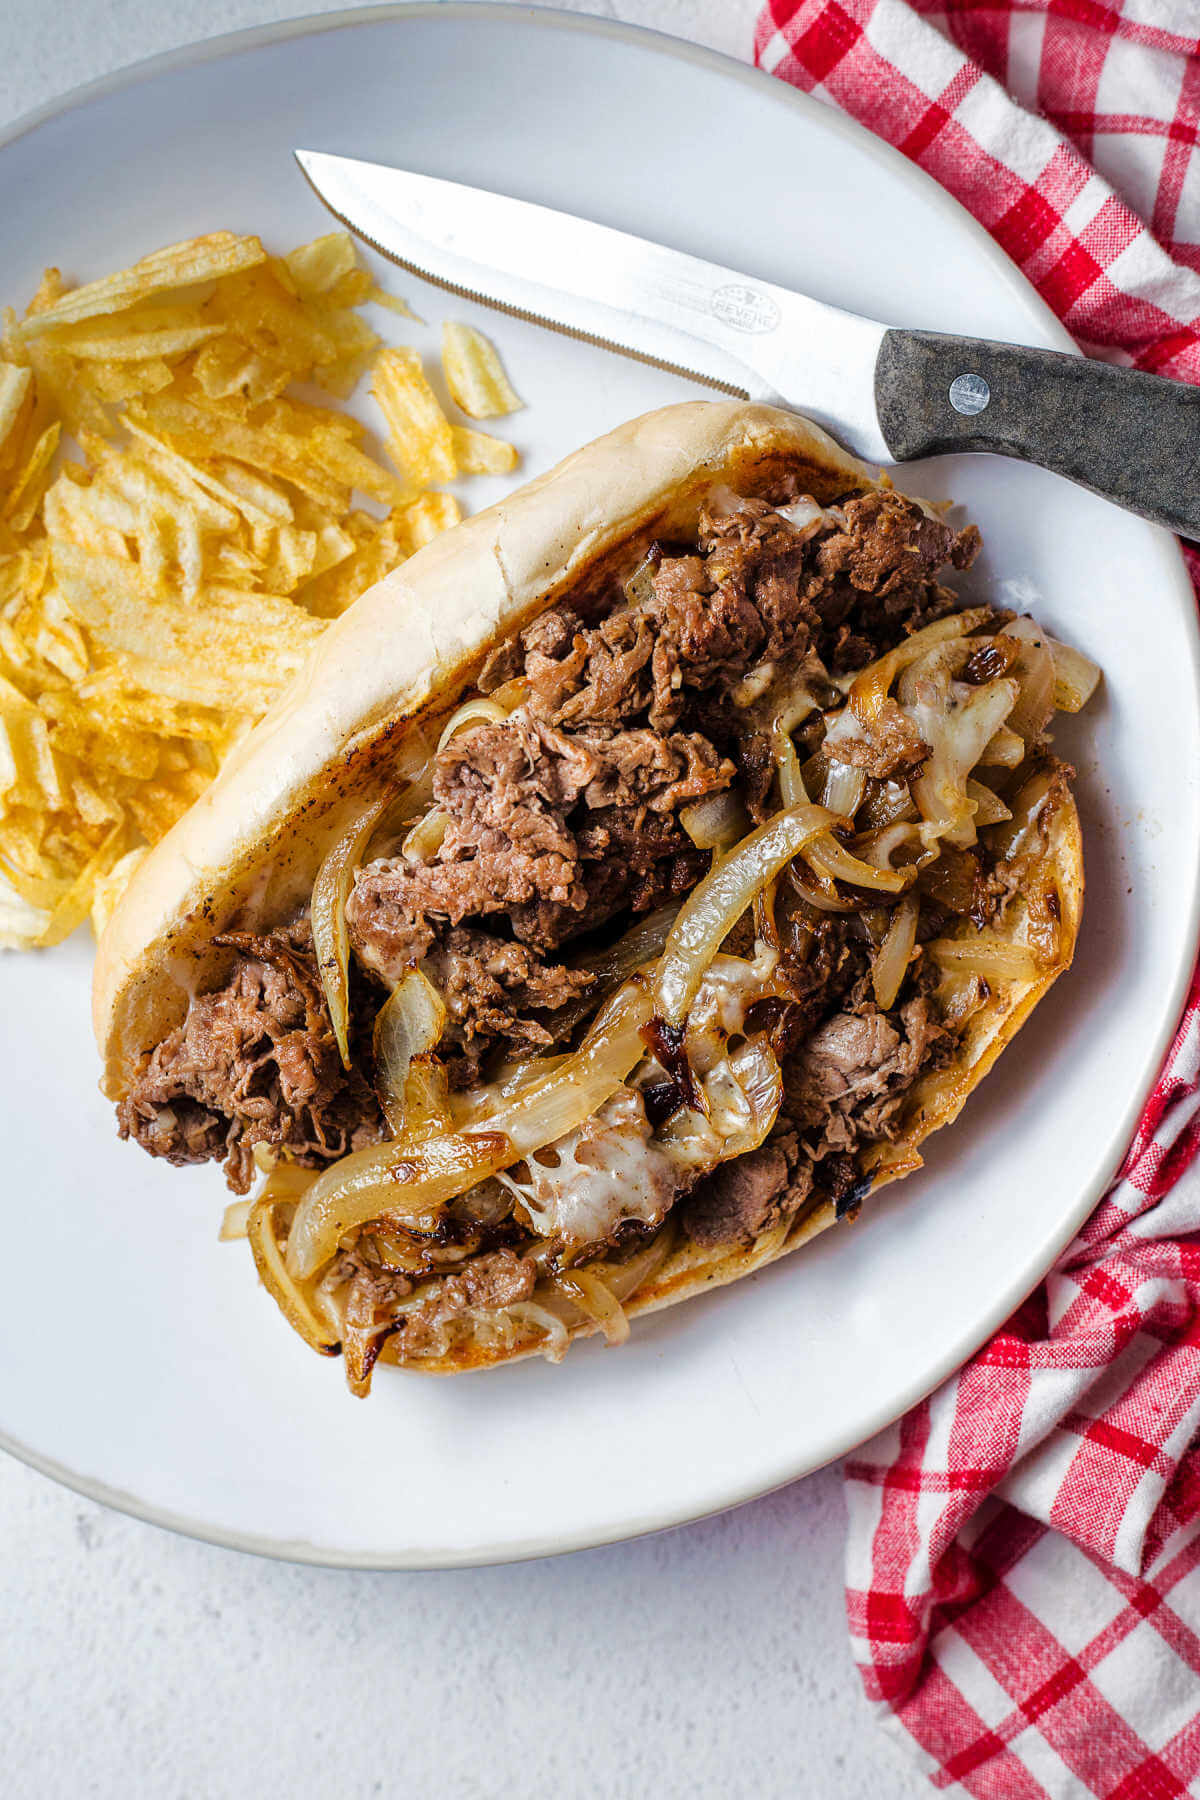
347,491,972,1039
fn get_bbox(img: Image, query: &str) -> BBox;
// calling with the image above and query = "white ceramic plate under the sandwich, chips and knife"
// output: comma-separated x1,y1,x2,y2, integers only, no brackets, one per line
0,5,1200,1566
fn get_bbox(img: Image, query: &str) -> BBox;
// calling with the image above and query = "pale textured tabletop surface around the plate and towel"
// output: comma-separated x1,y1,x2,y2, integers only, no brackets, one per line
0,0,927,1800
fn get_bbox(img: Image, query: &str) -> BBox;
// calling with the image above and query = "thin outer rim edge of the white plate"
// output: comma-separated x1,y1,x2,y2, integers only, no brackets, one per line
0,0,1200,1570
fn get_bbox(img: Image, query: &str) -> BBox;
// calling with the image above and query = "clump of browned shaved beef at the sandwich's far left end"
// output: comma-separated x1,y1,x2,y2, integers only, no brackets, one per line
117,923,383,1193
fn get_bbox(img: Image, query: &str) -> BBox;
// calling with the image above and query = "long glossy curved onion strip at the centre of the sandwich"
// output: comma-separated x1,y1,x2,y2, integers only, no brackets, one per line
655,806,834,1026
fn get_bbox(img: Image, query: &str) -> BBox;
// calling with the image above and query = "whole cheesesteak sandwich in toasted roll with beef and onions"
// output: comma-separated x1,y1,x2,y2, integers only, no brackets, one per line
95,401,1097,1393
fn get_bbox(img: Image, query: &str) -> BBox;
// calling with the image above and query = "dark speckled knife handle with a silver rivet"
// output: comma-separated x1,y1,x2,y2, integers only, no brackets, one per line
874,331,1200,540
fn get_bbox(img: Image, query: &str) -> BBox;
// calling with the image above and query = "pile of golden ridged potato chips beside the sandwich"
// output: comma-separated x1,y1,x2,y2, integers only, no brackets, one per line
0,232,516,947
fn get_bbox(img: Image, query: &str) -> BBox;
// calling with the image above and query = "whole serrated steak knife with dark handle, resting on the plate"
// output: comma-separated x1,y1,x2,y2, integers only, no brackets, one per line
295,149,1200,540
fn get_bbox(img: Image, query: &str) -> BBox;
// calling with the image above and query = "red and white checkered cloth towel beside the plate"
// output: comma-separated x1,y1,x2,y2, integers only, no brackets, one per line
756,0,1200,1800
